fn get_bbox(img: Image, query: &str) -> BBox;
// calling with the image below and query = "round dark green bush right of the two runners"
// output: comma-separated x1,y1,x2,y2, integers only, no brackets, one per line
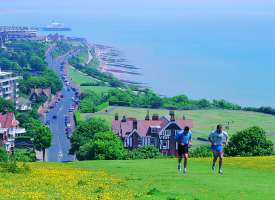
225,126,273,156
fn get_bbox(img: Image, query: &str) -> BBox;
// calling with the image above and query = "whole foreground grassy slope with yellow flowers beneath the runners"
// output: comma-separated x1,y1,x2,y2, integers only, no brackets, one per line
0,157,275,200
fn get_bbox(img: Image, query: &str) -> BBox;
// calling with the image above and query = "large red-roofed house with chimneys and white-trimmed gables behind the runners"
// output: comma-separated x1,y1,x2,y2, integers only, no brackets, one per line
112,111,193,155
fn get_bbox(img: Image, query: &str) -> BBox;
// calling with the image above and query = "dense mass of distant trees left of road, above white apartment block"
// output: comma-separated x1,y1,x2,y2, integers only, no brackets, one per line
0,41,62,94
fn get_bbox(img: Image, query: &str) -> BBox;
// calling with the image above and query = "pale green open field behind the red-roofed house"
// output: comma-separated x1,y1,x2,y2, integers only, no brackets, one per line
85,107,275,142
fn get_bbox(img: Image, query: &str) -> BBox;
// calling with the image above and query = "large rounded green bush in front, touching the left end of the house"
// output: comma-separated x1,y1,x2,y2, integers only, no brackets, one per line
76,131,125,160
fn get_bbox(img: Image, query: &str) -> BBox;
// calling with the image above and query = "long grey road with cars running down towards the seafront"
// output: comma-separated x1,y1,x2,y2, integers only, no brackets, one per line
43,47,79,162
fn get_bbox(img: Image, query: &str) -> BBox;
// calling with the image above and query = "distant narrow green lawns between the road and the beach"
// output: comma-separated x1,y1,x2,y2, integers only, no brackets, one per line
68,66,111,93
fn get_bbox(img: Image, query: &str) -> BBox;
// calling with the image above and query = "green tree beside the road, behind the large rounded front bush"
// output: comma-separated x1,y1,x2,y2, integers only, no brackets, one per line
70,118,110,153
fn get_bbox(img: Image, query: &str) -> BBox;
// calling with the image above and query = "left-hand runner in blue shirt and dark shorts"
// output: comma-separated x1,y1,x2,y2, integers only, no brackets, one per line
176,126,192,173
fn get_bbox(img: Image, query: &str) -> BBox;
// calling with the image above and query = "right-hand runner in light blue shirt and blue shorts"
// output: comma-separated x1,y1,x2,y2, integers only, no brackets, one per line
208,124,228,174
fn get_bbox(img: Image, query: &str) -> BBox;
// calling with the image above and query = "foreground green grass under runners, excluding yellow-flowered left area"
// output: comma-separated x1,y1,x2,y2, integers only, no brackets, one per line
67,157,275,200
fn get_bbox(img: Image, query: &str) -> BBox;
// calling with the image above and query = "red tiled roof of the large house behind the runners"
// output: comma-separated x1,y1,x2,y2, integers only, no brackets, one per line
112,118,193,137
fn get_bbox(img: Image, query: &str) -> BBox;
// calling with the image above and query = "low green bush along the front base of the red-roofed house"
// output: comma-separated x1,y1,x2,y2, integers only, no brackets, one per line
126,145,162,160
